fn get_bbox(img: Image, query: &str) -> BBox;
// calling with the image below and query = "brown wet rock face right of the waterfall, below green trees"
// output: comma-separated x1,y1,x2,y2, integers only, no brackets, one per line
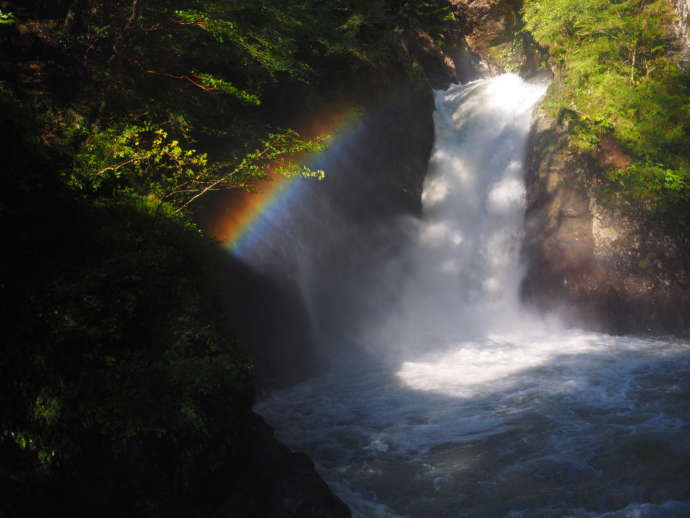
523,111,690,333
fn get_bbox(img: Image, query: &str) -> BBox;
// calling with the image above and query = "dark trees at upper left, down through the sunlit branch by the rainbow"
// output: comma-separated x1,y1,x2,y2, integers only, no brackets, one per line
3,0,453,212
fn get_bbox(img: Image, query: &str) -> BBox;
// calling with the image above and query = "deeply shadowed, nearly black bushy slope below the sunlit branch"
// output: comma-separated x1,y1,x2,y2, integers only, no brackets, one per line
0,95,253,516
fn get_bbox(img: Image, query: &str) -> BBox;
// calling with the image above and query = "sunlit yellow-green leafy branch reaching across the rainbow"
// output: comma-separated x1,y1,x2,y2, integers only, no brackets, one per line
63,124,327,212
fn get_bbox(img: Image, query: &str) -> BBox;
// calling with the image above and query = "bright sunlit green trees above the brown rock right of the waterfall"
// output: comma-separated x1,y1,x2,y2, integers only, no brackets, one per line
524,0,690,232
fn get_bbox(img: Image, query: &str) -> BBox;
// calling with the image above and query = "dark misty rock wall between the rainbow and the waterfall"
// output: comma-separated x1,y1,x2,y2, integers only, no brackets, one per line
208,70,433,391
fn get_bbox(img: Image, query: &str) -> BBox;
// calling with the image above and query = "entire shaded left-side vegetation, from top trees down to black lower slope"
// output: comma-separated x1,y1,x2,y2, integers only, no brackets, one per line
0,0,453,516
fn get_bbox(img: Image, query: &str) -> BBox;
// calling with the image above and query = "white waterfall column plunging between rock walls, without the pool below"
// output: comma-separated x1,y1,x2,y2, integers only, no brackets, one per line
363,74,546,354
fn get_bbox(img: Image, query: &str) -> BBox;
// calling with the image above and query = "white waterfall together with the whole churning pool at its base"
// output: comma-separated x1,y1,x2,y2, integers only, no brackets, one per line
256,75,690,518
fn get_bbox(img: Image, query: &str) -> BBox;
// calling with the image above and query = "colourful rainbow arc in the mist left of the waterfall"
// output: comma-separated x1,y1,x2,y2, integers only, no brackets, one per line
206,106,361,257
